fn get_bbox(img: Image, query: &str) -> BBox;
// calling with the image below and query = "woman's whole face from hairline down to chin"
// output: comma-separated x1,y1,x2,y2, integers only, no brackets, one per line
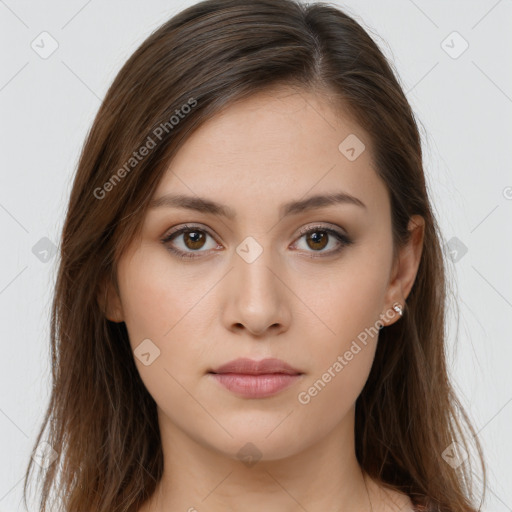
110,89,419,460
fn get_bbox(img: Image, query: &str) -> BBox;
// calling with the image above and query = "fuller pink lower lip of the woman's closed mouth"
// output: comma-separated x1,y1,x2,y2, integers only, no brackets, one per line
211,373,301,398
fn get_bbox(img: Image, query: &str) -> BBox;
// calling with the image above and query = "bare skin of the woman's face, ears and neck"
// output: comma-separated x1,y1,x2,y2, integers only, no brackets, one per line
101,88,424,512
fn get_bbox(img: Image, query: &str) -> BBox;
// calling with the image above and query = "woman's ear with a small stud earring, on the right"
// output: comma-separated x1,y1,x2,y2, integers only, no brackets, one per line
381,215,425,325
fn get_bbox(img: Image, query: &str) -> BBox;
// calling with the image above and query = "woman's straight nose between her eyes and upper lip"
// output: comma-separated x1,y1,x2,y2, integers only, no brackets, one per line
222,242,291,337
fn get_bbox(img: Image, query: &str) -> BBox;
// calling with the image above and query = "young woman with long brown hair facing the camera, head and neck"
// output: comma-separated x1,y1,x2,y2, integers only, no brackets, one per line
25,0,485,512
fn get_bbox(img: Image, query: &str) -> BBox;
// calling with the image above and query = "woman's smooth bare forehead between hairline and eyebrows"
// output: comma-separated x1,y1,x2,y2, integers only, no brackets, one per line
154,87,387,220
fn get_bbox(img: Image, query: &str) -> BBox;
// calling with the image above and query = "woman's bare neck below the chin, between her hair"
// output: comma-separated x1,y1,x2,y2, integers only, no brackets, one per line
143,411,372,512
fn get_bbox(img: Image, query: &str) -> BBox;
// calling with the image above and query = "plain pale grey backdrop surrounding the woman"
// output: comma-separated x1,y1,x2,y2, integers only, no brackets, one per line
0,0,512,512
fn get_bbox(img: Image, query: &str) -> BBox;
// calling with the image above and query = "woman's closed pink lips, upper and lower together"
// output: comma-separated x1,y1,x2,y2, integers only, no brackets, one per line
210,358,302,398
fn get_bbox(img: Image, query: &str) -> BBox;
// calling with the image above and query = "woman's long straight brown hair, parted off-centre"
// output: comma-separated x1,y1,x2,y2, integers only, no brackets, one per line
24,0,486,512
